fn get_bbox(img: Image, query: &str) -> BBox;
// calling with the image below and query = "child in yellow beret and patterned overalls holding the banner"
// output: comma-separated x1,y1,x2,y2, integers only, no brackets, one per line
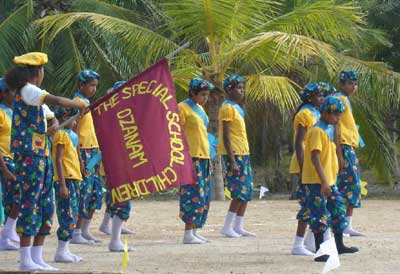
6,52,86,271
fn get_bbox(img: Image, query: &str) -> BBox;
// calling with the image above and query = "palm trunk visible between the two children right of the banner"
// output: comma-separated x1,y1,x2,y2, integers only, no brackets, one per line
206,92,225,201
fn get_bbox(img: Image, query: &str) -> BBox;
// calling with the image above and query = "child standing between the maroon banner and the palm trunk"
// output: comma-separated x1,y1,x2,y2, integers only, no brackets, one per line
178,78,214,244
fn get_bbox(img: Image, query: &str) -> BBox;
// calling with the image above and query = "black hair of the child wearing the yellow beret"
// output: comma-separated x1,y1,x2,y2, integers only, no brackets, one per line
5,66,43,90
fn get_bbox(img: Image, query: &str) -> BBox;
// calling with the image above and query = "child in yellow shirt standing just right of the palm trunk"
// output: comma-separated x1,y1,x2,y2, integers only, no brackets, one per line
218,74,255,238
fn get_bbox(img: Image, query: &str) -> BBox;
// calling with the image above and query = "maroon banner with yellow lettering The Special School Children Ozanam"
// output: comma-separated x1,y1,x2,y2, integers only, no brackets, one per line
90,59,196,203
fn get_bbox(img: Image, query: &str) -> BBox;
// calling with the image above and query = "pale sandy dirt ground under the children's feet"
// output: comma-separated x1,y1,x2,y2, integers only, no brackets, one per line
0,200,400,274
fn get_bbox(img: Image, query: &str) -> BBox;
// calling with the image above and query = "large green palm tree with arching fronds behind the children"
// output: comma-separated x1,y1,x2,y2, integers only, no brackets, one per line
3,0,400,199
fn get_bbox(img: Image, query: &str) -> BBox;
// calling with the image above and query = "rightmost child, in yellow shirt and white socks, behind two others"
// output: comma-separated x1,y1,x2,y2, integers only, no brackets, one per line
335,70,365,236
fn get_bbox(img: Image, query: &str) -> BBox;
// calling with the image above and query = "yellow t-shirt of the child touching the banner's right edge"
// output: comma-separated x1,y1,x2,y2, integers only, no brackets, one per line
178,102,210,159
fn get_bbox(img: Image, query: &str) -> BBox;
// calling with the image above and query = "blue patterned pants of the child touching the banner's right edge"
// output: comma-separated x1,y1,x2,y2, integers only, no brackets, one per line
179,158,211,228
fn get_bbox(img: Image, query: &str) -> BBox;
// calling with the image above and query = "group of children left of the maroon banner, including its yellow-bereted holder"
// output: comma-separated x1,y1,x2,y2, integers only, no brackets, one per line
0,52,132,270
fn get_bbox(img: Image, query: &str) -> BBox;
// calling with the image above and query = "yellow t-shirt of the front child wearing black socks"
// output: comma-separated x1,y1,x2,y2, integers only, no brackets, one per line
302,124,339,185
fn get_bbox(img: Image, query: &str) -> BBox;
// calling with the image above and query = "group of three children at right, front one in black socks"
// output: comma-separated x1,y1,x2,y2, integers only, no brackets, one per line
290,71,364,261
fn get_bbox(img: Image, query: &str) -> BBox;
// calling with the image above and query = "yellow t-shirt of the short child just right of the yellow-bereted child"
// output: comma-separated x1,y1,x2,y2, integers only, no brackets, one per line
52,130,82,181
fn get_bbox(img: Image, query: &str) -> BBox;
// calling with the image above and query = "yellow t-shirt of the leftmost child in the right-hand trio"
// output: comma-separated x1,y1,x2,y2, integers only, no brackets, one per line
289,108,318,174
